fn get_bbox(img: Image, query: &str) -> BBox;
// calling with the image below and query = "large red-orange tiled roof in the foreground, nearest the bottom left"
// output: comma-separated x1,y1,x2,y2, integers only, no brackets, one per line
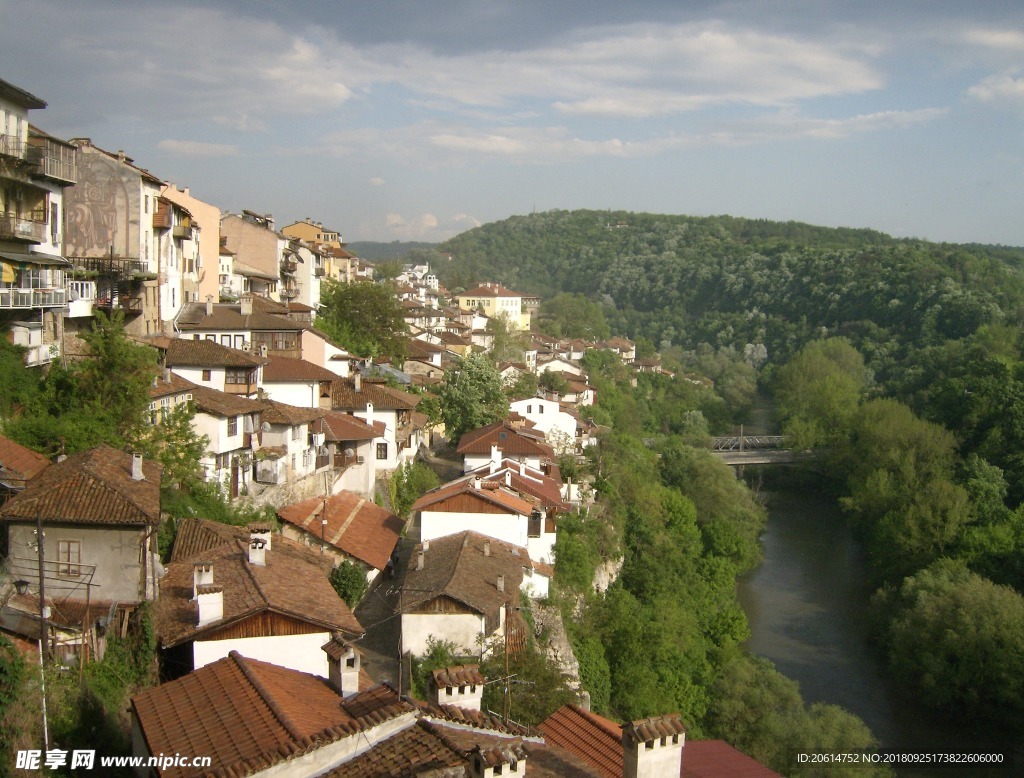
132,651,416,778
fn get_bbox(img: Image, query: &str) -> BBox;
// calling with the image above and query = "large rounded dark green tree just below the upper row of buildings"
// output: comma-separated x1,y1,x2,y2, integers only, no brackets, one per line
316,280,409,364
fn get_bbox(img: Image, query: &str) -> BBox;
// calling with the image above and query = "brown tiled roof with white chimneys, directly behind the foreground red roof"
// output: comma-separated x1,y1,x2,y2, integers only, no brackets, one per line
155,533,362,648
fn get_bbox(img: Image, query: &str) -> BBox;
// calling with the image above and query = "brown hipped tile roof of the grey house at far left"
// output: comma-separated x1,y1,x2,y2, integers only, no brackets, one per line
0,445,164,526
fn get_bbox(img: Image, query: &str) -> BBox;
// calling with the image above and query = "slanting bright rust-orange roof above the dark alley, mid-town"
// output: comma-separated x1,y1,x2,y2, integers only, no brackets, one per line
278,490,403,570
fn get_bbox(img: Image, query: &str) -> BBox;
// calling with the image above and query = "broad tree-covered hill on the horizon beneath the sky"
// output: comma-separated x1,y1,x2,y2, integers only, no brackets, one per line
438,211,1024,370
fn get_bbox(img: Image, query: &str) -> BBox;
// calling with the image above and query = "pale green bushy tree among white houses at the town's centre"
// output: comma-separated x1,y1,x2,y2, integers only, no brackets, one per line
437,354,508,441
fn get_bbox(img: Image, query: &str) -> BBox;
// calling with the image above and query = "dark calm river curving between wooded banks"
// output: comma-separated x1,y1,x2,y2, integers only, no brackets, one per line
738,470,1024,776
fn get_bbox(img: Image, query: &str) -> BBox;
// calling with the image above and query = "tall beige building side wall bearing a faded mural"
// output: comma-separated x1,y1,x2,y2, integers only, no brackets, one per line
65,145,141,259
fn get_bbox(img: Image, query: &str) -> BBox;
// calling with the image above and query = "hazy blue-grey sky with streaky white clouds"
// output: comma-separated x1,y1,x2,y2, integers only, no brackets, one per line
0,0,1024,246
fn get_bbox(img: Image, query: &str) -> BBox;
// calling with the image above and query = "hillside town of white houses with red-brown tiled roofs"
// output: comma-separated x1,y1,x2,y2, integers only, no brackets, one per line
0,81,775,777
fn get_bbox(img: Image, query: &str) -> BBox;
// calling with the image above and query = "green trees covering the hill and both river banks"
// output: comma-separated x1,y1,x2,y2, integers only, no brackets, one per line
439,211,1024,772
